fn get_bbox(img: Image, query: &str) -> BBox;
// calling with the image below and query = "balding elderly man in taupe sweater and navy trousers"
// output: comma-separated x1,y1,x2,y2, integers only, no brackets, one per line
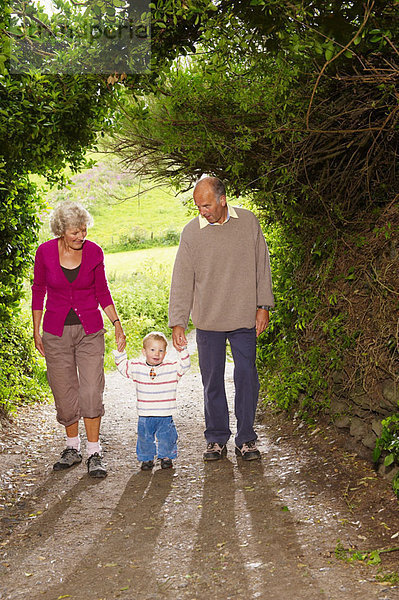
169,177,274,461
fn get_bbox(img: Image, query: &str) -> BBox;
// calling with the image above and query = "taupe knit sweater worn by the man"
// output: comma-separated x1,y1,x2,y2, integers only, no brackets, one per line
169,208,274,331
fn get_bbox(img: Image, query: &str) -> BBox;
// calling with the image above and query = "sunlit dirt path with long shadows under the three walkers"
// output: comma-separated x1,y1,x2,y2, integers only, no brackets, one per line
0,336,399,600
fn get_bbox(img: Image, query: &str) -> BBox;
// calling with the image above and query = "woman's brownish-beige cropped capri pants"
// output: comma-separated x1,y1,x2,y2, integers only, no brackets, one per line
42,325,105,427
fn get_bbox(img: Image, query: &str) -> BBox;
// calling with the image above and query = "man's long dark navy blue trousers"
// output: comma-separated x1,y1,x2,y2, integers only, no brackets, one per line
197,327,259,446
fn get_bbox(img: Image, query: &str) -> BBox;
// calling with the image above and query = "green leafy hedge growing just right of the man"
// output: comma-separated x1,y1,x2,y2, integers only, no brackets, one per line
258,221,351,418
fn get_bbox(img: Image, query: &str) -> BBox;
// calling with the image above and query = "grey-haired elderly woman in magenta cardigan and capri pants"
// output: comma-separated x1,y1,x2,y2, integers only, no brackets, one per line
32,201,126,477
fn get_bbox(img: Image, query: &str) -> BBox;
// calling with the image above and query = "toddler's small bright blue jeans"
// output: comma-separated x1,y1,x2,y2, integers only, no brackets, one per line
136,416,178,462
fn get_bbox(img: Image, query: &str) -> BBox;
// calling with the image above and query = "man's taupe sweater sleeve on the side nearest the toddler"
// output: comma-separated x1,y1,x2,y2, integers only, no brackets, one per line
169,232,195,329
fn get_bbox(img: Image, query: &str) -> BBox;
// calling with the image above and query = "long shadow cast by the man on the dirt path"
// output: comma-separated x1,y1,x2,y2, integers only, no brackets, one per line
184,460,326,600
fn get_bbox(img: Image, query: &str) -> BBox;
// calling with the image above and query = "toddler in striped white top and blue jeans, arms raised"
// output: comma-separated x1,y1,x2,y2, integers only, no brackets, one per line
113,331,190,471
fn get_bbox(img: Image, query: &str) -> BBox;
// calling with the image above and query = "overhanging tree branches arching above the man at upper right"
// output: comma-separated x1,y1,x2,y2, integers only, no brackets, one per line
111,0,399,225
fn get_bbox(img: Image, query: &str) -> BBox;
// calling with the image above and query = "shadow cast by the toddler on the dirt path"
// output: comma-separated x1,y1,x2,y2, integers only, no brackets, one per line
38,470,173,600
